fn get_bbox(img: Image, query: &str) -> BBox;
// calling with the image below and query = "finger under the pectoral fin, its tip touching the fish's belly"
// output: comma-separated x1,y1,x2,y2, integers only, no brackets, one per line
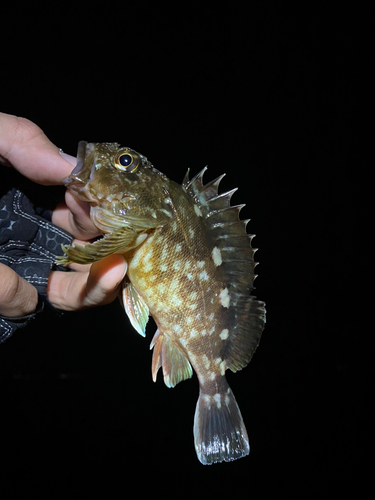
47,254,127,311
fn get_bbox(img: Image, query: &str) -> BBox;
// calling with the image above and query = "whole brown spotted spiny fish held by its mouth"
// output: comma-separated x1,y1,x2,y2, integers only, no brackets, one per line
57,141,266,464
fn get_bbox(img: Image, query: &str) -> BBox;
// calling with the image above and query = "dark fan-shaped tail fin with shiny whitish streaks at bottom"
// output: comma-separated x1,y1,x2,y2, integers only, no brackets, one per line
194,386,250,465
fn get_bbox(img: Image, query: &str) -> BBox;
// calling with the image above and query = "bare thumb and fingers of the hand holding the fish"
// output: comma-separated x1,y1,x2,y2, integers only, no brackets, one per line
0,113,127,317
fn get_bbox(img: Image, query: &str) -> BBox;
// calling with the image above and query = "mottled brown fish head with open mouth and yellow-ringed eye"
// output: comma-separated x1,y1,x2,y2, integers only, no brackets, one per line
63,141,172,232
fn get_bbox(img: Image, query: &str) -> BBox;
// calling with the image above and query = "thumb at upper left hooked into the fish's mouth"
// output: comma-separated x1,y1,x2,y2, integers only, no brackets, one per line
0,113,72,185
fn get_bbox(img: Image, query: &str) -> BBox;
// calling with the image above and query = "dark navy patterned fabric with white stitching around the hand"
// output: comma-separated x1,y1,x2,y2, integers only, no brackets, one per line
0,188,72,343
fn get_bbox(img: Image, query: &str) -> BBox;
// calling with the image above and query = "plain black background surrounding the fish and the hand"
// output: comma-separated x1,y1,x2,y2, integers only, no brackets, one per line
0,2,373,499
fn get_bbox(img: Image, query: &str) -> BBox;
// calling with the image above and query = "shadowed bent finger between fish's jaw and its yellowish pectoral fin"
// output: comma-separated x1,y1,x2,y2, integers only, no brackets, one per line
52,191,101,240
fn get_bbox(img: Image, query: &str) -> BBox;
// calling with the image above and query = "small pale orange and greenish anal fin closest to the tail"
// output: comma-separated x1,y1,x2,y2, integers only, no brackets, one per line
150,330,193,387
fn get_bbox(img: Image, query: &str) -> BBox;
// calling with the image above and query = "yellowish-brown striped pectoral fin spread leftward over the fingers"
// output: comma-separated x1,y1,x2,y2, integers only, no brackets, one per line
56,227,147,265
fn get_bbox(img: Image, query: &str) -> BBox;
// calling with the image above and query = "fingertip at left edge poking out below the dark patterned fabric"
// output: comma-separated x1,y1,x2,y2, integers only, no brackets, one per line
0,264,38,318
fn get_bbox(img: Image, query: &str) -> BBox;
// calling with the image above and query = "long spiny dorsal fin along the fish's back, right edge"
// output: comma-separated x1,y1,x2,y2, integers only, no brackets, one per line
182,167,265,371
